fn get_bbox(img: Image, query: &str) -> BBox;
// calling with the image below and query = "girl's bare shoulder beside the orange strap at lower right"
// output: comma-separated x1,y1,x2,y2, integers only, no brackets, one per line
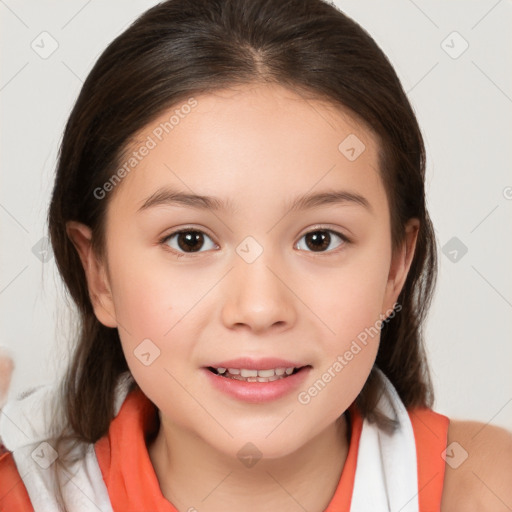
441,419,512,512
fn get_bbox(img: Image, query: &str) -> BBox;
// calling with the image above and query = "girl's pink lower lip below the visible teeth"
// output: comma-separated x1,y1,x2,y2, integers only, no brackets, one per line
202,366,311,403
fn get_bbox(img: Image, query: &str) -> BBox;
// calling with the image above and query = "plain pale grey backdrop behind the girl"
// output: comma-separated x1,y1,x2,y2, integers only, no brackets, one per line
0,0,512,429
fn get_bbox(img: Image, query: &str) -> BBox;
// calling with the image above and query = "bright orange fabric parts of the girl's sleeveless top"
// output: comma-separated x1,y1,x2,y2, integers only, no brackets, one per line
0,389,449,512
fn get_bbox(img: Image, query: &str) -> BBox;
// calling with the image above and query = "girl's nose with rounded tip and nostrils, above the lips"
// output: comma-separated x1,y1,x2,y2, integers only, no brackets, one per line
222,252,297,334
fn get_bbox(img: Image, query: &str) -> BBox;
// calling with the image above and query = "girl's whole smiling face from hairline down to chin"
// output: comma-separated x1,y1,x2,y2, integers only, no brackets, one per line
72,85,416,458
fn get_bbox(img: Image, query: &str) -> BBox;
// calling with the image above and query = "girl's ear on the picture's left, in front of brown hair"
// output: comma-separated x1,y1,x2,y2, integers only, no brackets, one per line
66,221,117,327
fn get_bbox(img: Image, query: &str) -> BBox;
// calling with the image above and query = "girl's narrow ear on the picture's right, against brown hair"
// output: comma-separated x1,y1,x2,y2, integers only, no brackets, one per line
382,219,420,316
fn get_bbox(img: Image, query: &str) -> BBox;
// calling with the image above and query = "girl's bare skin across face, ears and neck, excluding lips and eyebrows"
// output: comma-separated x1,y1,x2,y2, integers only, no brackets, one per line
63,84,512,512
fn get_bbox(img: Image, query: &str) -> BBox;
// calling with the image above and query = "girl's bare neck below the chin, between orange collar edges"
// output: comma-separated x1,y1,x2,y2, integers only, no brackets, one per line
148,416,349,512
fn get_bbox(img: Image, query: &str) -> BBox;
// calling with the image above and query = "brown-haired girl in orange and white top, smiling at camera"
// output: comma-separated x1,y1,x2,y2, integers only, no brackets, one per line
0,0,512,512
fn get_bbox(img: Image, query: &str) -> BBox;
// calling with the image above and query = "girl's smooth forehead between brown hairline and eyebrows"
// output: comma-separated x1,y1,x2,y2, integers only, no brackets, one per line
112,84,388,215
